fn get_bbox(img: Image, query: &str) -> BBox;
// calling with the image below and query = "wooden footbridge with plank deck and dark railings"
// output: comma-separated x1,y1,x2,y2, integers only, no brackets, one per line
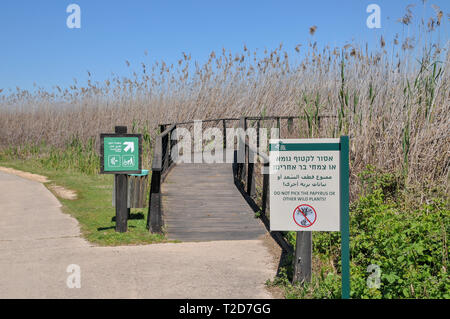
147,116,334,244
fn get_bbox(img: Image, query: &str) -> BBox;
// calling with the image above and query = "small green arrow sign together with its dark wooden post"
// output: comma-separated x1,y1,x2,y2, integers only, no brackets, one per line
100,126,142,232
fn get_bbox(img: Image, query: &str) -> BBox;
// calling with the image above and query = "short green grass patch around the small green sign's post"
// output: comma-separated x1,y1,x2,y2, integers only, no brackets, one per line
0,159,166,246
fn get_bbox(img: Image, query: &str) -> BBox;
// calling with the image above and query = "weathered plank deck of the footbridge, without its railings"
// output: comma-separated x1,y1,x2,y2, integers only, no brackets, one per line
161,163,266,241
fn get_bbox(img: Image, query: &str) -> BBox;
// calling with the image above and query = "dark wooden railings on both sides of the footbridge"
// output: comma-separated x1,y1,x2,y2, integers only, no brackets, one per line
147,115,335,235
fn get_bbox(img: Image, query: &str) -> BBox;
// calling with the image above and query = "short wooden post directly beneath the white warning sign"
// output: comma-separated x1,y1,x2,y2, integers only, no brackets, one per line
292,231,312,284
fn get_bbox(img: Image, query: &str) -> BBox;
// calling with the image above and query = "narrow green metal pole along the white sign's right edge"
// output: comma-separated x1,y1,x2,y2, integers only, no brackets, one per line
340,136,350,299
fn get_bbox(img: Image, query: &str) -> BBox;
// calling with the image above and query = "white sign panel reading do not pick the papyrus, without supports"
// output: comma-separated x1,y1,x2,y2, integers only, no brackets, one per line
269,139,340,231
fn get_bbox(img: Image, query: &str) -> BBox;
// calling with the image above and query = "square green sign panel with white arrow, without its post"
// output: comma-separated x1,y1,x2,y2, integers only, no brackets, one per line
100,134,141,174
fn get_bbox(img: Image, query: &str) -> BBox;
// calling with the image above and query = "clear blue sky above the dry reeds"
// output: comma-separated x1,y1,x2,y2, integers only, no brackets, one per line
0,0,450,93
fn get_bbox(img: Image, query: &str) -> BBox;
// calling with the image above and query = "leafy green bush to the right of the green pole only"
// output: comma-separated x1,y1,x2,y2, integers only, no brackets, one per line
351,189,450,298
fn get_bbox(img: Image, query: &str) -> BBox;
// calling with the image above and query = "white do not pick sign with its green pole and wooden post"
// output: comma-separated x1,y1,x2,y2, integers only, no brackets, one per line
269,136,350,298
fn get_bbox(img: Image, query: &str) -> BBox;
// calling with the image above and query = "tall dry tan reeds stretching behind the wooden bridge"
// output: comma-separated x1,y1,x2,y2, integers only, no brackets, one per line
0,3,450,195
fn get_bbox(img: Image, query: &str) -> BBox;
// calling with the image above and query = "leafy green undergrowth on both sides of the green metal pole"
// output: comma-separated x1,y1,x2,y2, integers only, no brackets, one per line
271,166,450,299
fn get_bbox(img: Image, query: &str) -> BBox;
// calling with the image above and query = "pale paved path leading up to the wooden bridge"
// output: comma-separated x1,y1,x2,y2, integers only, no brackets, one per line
0,172,277,298
